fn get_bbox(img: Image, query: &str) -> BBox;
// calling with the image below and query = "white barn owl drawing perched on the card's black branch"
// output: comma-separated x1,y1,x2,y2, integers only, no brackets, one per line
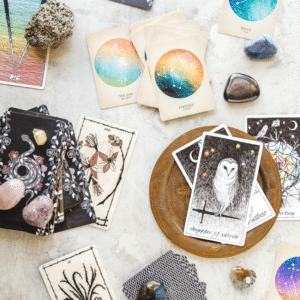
213,158,239,217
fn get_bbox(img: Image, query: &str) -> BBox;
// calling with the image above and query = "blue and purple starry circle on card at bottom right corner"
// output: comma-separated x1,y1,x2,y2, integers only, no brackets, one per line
275,257,300,300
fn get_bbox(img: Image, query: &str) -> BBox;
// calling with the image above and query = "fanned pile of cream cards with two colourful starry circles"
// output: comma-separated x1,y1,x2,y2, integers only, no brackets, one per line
87,11,214,121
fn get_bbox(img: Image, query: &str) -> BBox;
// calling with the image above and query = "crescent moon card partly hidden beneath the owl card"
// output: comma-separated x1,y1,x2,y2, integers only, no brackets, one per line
173,124,275,231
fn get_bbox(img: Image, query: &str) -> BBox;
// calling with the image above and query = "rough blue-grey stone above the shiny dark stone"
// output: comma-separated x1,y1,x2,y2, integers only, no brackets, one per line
244,34,278,59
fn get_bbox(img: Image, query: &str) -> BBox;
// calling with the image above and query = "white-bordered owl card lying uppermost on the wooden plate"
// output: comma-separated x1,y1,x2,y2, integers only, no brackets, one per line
184,133,262,246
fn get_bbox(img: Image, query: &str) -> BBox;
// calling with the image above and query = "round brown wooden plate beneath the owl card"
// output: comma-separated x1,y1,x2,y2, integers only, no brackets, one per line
150,126,281,258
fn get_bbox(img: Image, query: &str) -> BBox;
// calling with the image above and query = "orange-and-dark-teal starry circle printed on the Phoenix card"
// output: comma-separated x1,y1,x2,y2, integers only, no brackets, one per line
155,49,204,98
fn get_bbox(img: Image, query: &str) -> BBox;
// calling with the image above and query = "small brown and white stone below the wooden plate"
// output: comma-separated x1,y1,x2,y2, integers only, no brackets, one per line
230,267,256,291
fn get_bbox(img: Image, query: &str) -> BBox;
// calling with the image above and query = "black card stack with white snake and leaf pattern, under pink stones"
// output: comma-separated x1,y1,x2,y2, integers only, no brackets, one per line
0,106,95,235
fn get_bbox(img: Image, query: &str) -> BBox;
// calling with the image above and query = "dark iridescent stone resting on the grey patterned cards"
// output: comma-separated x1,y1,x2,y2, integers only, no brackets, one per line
136,281,168,300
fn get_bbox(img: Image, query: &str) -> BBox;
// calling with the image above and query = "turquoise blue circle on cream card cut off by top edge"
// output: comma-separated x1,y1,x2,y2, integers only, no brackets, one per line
229,0,277,22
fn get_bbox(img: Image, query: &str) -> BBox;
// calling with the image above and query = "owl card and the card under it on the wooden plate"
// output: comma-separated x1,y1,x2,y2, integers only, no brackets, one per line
173,125,275,246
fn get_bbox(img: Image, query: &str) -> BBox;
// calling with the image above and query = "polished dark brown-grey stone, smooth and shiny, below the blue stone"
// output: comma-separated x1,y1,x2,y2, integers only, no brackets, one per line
224,73,260,103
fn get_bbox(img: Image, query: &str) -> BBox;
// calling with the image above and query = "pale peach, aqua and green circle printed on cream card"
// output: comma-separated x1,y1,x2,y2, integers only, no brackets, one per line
95,38,142,87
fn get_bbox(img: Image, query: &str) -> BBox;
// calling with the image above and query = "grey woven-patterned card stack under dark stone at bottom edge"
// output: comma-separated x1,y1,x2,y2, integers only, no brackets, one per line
123,251,207,300
